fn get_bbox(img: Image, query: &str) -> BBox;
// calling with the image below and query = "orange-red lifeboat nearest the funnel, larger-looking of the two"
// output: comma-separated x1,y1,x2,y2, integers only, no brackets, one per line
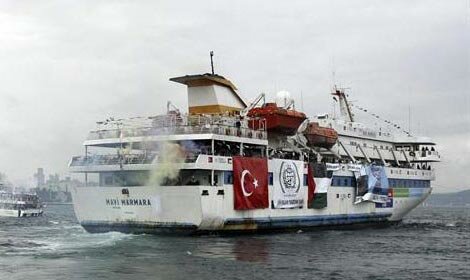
247,103,307,135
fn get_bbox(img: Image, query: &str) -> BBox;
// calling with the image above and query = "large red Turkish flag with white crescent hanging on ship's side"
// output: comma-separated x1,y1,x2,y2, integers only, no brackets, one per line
233,156,269,210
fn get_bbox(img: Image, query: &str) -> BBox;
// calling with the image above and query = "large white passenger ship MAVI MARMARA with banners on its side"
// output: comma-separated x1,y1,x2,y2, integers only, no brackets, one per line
69,68,440,233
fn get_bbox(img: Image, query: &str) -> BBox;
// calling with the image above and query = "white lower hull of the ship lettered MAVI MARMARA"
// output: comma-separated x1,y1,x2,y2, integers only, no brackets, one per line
72,182,430,234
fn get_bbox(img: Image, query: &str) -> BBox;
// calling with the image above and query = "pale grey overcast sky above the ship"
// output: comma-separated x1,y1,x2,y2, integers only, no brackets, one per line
0,0,470,192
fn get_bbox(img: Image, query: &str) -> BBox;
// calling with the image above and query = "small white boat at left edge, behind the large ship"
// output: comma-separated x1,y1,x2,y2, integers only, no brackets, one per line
0,191,43,217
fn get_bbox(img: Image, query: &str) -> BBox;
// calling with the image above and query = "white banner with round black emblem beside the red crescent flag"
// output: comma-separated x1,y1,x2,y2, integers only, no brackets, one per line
270,159,305,208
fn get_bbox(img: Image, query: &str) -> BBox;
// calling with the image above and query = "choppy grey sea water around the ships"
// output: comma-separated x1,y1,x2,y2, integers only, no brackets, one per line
0,205,470,280
